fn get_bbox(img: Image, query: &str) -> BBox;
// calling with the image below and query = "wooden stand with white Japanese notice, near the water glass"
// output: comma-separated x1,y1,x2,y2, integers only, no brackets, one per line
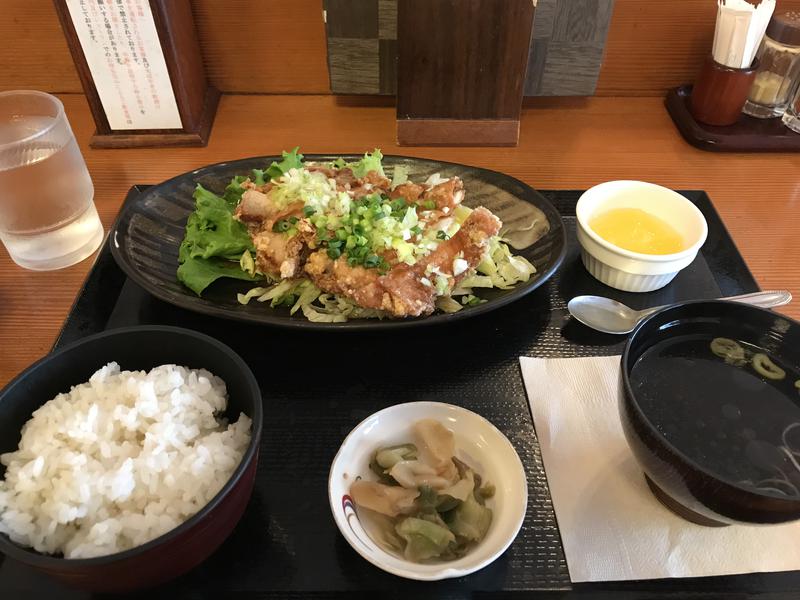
53,0,220,148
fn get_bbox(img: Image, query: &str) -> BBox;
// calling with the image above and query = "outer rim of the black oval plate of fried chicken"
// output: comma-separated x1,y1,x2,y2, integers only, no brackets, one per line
108,153,567,331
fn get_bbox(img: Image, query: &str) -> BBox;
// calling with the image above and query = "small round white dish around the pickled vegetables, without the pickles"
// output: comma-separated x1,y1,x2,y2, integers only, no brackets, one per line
328,402,528,581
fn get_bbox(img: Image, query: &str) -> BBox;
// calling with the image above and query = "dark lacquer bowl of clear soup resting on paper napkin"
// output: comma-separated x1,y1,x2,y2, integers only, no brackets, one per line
619,301,800,526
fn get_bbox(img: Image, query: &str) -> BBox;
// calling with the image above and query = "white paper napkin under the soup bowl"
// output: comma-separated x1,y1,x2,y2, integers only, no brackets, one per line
520,356,800,583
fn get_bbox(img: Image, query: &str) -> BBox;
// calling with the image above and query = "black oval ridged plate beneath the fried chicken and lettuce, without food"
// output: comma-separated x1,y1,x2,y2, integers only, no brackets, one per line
109,155,567,330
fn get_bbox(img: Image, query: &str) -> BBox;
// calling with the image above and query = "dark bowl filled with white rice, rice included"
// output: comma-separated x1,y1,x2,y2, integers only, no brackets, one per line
0,326,262,592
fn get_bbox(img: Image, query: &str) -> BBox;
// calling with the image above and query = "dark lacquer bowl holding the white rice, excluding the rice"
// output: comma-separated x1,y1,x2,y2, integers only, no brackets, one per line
0,326,262,592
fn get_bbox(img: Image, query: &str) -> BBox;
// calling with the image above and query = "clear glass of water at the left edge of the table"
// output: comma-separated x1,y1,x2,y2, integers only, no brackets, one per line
0,91,103,271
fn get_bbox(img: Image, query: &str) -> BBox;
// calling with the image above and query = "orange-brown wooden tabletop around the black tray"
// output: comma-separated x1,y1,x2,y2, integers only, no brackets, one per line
0,95,800,385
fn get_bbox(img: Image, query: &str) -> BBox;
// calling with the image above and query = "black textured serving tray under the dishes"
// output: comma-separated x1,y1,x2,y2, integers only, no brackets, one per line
0,187,800,600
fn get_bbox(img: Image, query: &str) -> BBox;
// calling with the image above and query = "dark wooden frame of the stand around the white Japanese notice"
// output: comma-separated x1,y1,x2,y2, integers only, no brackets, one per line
53,0,220,148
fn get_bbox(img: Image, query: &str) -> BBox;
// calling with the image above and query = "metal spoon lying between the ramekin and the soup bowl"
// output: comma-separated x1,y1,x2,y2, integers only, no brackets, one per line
567,290,792,335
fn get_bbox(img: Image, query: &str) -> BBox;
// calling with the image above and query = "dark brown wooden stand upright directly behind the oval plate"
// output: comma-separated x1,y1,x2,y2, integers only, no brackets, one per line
397,0,534,146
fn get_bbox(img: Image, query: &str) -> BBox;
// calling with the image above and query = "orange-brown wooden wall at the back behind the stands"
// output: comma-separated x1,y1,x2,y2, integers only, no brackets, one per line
6,0,800,96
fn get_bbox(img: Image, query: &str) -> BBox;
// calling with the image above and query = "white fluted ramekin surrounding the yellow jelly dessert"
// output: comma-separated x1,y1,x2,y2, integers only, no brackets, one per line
575,181,708,292
